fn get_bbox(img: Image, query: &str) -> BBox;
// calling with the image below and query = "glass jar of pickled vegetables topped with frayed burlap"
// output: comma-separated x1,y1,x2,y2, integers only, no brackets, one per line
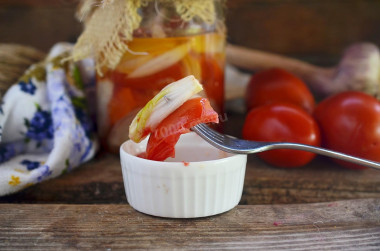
72,0,225,151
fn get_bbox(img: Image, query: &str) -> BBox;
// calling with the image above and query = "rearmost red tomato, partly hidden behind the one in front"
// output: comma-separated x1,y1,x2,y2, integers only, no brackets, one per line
246,68,315,113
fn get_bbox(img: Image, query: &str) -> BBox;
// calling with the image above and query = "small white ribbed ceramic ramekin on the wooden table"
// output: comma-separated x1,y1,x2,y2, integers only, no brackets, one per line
120,132,247,218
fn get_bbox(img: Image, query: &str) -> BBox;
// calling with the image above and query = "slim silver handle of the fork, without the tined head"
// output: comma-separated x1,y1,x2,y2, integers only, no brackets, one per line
268,142,380,170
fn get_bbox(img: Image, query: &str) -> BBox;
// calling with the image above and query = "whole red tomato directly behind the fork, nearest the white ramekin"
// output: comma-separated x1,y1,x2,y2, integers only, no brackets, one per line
243,103,320,167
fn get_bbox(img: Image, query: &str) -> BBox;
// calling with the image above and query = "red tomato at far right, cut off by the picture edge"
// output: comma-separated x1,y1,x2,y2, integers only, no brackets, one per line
314,91,380,169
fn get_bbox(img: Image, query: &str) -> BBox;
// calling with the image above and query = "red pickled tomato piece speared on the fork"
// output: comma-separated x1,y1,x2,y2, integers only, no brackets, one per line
146,98,219,161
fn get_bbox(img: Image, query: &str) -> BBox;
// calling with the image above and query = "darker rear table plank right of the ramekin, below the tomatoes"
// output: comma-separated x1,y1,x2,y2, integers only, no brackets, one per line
241,158,380,205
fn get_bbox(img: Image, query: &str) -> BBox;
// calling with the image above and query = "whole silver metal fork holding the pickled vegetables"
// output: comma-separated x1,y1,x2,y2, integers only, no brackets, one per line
191,124,380,170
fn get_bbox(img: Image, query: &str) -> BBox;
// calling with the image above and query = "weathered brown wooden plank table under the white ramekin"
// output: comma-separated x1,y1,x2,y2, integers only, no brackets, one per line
0,107,380,250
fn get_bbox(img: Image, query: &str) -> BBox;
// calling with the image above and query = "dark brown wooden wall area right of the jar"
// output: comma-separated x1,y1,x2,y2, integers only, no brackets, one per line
227,0,380,64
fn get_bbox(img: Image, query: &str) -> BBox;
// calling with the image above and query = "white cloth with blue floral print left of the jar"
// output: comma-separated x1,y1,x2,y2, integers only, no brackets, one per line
0,43,98,196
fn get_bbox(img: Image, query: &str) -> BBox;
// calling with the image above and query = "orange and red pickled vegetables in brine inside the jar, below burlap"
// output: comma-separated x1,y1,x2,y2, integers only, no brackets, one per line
97,0,225,151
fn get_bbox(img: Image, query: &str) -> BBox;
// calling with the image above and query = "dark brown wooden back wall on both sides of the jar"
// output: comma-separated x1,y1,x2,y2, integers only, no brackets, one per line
0,0,380,65
